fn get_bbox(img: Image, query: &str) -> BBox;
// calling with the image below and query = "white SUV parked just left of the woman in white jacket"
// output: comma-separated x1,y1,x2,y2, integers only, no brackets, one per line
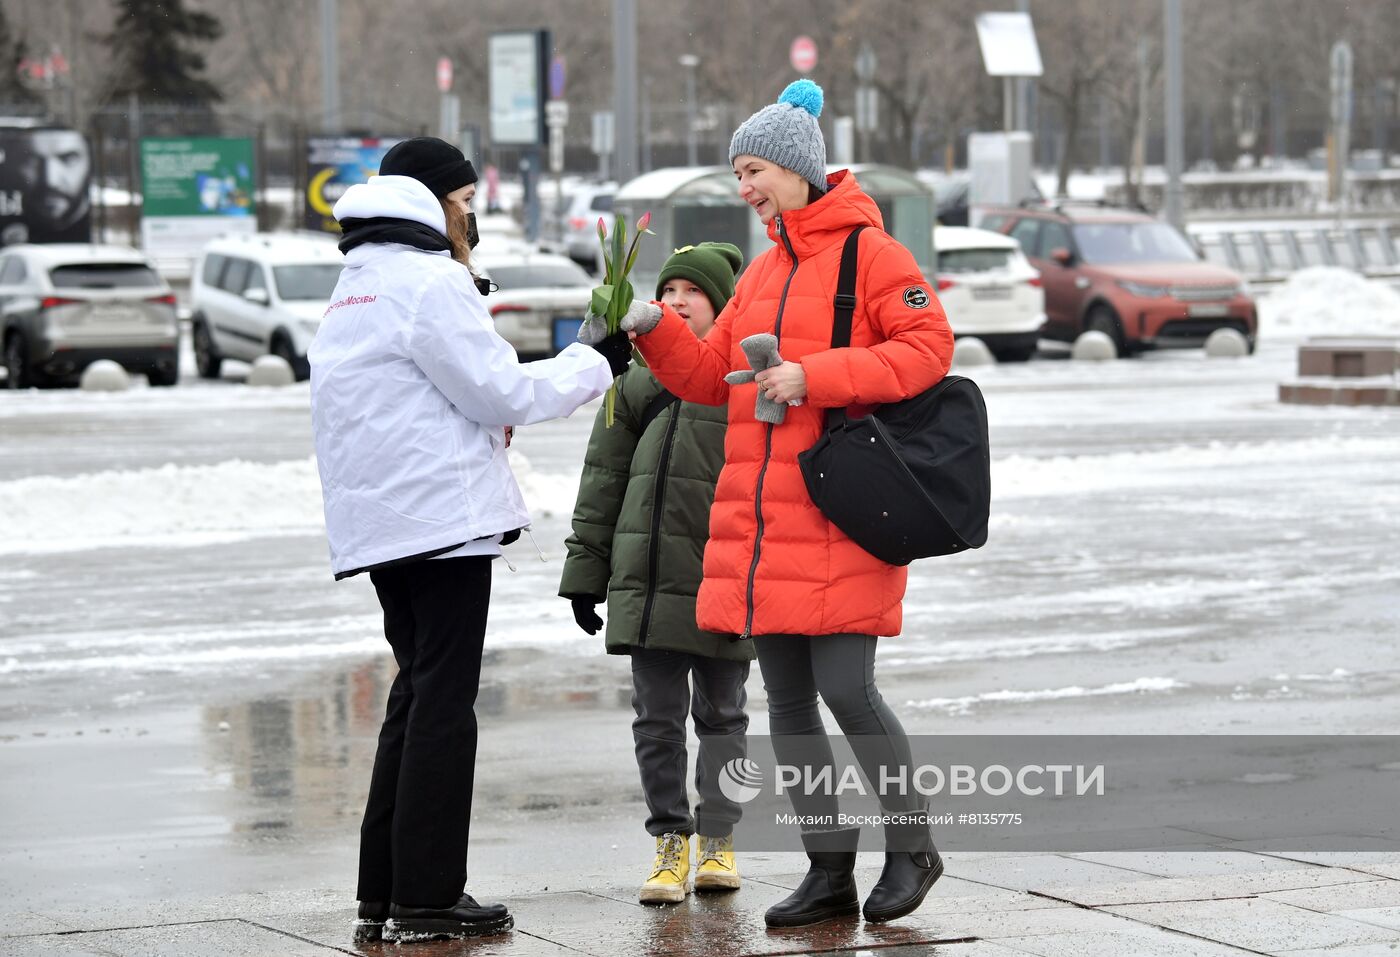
190,234,344,379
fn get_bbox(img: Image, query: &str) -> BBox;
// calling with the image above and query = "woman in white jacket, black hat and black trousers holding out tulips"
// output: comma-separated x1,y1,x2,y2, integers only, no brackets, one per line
309,137,631,940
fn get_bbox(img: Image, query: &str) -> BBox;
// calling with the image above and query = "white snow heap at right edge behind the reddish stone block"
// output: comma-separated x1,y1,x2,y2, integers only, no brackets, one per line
1259,266,1400,339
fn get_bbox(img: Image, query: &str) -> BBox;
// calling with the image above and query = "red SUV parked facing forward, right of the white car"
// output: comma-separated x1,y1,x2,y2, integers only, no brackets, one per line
980,203,1259,355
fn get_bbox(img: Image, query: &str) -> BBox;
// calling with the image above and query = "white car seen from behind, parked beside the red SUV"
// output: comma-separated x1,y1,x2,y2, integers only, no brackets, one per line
934,227,1046,362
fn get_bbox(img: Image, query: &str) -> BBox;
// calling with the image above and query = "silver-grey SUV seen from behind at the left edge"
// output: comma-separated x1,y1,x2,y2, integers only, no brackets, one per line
0,243,179,389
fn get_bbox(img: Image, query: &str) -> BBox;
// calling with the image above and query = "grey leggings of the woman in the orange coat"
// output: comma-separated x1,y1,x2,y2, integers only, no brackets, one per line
755,635,924,820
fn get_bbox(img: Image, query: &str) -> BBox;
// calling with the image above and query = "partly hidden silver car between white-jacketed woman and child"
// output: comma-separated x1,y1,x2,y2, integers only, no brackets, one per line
473,252,596,358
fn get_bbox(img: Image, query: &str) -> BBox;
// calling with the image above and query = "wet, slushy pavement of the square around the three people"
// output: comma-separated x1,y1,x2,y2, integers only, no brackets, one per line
0,335,1400,957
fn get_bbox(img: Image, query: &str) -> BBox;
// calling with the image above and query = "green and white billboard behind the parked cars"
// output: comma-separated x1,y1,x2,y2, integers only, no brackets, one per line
141,136,258,257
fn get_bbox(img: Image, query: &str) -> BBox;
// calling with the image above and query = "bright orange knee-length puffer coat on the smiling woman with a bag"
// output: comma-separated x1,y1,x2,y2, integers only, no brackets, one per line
637,171,953,637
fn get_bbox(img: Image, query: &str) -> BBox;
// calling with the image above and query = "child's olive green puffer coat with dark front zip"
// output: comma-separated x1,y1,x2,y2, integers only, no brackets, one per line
559,365,753,660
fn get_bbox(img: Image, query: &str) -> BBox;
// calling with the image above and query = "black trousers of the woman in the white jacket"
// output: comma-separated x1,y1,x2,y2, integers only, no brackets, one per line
357,555,491,907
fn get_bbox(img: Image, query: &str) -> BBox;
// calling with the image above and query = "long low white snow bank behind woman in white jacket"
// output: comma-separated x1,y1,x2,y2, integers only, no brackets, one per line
0,452,578,554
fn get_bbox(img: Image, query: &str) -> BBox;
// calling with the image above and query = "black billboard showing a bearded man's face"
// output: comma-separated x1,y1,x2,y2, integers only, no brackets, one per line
0,126,92,246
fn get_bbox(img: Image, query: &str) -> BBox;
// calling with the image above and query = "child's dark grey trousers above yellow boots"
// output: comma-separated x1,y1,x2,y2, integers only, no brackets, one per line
631,648,749,837
